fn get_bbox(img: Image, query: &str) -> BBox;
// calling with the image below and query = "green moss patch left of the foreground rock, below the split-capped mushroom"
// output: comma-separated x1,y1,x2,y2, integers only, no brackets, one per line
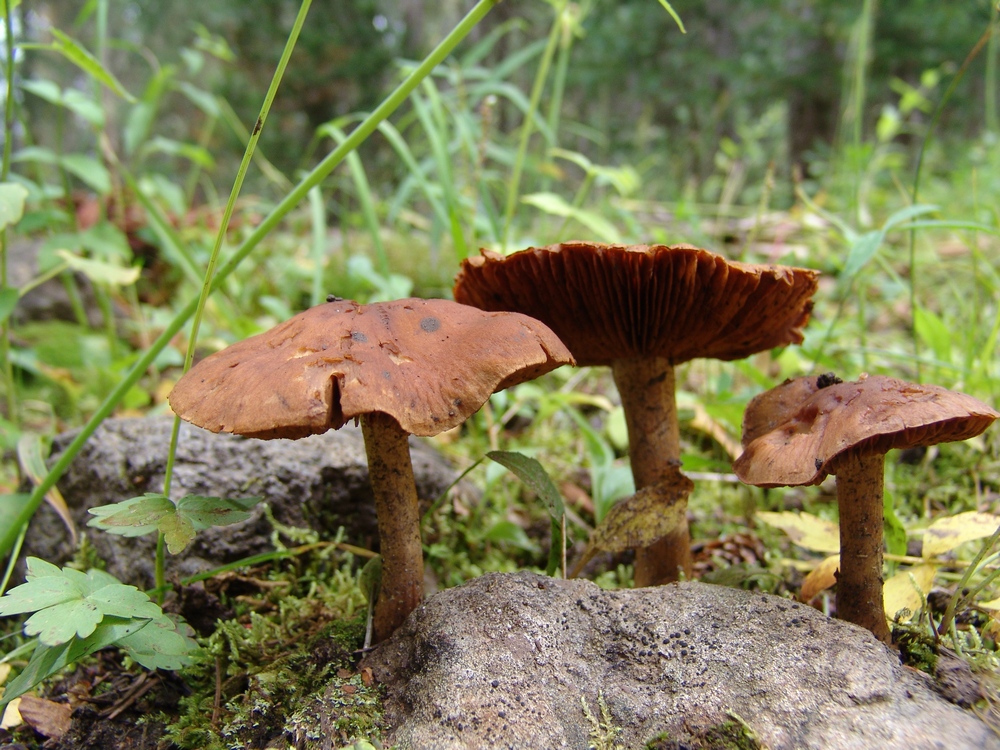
167,553,382,750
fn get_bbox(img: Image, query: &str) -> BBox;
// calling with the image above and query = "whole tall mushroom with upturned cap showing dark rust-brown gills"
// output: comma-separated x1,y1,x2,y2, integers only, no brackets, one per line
455,242,817,586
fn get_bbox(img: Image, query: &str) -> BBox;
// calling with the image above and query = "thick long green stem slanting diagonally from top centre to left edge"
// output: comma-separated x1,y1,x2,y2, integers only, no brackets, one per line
14,0,499,548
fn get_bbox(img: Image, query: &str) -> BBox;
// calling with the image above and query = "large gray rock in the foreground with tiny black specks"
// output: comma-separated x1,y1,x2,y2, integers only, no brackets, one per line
365,573,1000,750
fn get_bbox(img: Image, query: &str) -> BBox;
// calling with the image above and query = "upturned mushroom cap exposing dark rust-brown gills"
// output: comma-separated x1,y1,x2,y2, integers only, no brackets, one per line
454,242,817,365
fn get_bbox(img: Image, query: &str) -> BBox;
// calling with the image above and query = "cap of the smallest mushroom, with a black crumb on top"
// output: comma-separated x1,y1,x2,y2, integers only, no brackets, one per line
733,375,1000,487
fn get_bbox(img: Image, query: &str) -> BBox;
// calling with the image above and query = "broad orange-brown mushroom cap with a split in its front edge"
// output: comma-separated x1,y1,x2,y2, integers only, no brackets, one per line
169,299,573,439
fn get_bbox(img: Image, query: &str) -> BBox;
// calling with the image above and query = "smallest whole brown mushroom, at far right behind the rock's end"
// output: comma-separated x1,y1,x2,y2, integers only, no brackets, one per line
733,375,1000,643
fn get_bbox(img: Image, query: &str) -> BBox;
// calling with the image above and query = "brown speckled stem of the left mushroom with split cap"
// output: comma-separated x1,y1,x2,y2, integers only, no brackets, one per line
361,412,424,643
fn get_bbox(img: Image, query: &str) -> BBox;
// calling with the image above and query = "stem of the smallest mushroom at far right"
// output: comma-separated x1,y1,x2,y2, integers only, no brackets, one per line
835,451,892,643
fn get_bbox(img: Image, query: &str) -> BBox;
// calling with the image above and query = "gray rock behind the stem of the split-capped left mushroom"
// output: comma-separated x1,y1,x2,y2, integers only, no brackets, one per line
26,417,455,588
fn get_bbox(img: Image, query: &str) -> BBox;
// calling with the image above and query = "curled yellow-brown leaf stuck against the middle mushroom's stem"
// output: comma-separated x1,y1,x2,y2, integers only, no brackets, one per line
569,468,694,578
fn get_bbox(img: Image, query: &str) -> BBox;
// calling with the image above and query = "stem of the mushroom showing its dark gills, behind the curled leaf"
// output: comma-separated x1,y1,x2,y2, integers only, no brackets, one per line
611,357,691,587
